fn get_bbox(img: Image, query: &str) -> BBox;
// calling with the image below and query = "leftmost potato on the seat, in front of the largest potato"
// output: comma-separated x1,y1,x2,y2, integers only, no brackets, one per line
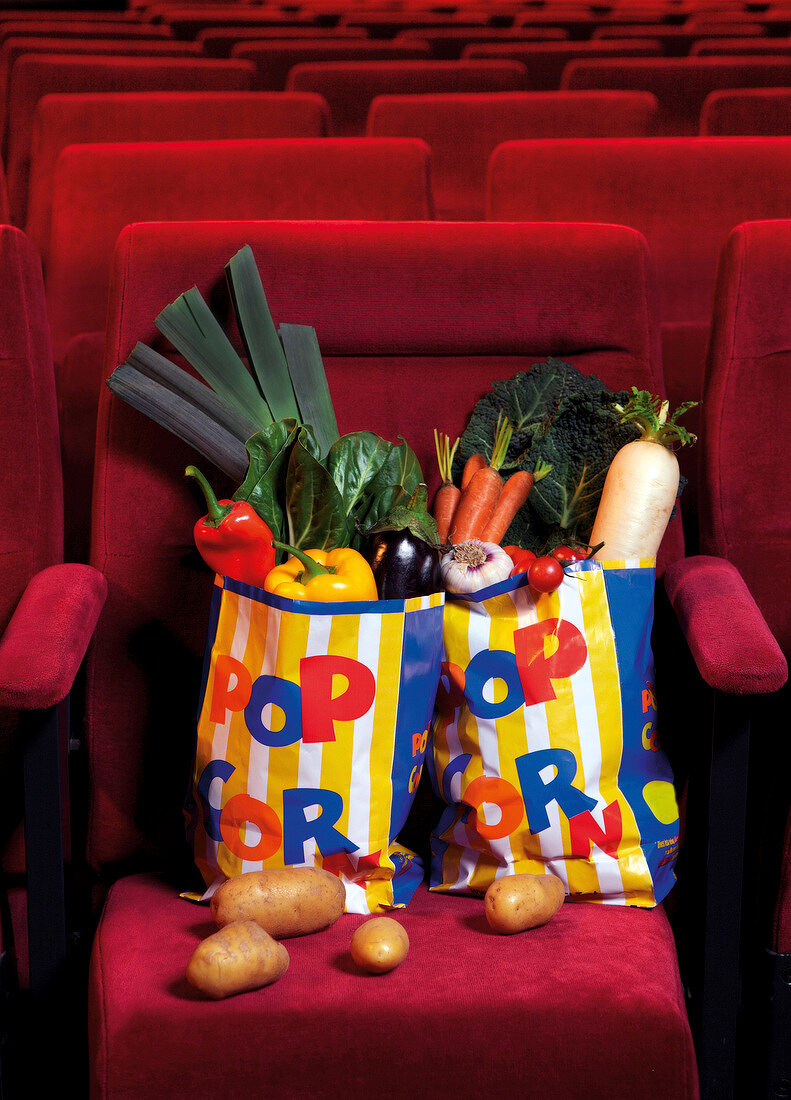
187,921,288,1001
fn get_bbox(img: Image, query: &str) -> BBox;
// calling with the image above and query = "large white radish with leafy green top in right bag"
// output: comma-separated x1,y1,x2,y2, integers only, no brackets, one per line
591,386,697,561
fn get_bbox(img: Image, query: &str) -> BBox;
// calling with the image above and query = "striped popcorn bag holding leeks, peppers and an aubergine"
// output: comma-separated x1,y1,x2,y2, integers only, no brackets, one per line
187,575,444,913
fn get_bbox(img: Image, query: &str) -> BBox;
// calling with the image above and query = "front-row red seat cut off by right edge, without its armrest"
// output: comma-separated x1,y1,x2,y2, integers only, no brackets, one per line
701,220,791,1096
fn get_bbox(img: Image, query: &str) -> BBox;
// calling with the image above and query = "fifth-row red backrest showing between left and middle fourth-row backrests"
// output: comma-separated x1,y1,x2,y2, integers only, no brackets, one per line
231,39,430,91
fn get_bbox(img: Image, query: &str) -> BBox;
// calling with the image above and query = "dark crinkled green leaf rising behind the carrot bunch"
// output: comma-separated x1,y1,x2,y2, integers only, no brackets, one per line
453,356,628,480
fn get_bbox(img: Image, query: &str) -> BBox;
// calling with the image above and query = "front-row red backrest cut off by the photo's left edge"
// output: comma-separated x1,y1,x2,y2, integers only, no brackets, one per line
0,224,63,633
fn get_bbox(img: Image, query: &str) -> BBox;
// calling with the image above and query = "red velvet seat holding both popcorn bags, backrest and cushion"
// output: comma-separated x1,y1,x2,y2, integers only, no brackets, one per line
87,214,711,1100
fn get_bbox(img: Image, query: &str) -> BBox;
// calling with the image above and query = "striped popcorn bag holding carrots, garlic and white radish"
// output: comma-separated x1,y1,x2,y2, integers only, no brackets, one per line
431,560,679,908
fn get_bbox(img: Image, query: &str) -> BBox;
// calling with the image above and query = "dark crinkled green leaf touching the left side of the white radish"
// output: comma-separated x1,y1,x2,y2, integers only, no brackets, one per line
529,392,639,541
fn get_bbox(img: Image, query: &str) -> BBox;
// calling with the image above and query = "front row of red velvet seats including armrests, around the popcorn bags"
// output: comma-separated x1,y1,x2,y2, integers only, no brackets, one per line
0,206,791,1100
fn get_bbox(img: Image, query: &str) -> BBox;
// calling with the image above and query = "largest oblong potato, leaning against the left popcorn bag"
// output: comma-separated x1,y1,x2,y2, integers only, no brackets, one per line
211,867,347,939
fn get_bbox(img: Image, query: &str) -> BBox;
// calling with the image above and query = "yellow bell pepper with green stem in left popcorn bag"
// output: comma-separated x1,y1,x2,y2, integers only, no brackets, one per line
264,541,377,603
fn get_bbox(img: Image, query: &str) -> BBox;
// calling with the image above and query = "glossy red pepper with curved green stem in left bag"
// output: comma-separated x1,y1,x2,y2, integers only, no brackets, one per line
184,466,275,589
